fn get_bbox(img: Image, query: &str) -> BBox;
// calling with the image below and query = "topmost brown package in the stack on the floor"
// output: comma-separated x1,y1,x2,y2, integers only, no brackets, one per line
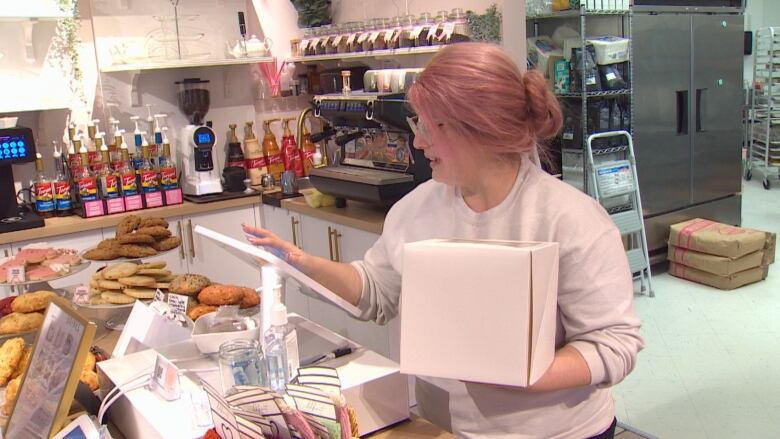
669,218,766,259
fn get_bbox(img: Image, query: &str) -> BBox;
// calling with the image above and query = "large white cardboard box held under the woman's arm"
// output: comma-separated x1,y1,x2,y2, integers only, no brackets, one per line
400,240,558,386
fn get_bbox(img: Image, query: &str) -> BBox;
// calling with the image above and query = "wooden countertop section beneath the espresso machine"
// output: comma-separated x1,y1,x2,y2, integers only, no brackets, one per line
280,197,387,235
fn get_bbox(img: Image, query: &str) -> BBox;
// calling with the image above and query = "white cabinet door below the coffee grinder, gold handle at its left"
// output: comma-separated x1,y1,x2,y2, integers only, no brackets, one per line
182,206,260,288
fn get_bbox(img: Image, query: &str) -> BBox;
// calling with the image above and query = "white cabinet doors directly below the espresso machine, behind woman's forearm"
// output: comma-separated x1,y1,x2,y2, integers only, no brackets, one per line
301,216,390,357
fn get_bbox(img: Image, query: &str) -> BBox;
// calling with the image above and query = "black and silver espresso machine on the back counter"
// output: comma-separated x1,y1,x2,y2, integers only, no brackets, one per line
309,91,431,208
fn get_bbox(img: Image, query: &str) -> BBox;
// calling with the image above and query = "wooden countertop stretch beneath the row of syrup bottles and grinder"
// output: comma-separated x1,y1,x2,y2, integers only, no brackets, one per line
0,194,260,245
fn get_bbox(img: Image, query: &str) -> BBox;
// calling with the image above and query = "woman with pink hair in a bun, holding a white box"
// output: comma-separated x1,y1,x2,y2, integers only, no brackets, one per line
245,43,643,439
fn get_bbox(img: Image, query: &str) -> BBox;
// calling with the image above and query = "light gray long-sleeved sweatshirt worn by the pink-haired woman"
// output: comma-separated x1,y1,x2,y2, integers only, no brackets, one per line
353,160,644,438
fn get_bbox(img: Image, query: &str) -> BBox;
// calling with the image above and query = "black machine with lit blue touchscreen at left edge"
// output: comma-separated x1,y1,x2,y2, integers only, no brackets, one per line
0,127,45,233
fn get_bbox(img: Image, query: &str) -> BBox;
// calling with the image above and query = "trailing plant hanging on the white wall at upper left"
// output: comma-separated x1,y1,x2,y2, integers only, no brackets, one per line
51,0,83,100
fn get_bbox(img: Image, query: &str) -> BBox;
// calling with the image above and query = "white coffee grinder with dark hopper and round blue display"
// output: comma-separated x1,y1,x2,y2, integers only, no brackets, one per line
176,78,222,196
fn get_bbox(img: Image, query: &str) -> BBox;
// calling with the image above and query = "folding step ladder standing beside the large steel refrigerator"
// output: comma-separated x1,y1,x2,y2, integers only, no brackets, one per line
586,131,655,297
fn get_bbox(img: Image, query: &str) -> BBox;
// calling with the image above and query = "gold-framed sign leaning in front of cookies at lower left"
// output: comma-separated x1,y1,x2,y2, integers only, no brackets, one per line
5,297,95,439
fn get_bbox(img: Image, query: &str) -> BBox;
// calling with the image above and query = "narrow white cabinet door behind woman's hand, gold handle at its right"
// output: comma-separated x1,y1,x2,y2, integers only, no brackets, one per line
261,205,310,319
